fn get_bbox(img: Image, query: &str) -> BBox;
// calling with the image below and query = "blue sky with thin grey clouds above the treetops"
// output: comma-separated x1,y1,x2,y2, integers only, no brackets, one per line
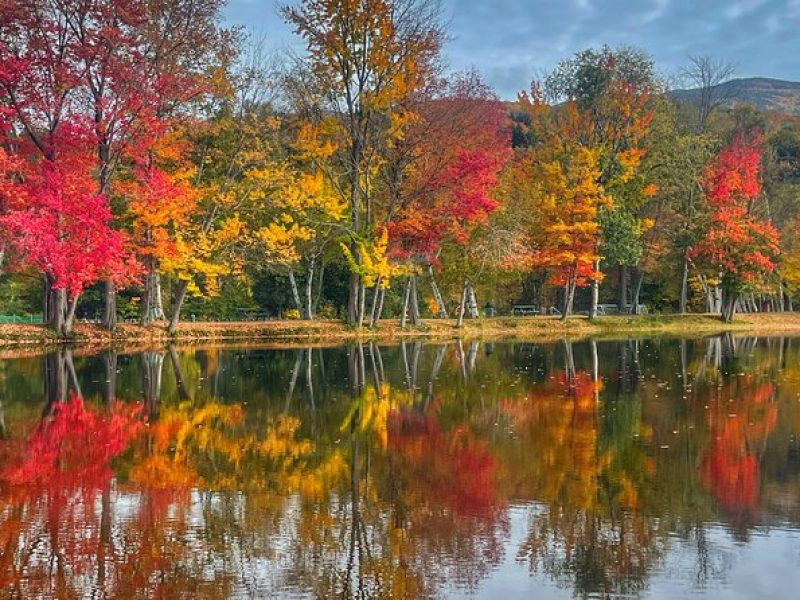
225,0,800,99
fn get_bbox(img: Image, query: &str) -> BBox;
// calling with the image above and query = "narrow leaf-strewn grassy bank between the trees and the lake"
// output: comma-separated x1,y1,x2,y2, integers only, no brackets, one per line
0,313,800,349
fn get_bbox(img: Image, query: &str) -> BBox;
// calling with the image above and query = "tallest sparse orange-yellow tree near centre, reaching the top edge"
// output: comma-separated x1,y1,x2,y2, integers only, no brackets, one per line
283,0,443,325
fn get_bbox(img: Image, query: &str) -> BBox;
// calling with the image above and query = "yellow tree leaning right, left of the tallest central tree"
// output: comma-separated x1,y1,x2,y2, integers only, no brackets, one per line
155,78,292,333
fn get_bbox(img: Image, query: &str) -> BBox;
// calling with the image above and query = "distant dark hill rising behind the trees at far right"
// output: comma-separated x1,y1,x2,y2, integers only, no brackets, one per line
668,77,800,116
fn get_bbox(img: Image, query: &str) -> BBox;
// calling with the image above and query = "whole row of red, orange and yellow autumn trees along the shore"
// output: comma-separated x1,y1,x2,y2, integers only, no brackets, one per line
0,0,800,334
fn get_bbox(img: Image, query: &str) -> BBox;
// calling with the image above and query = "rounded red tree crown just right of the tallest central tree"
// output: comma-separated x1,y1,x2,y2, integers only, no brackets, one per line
389,75,511,265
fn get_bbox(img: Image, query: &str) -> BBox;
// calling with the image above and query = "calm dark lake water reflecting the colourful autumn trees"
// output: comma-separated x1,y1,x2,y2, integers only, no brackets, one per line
0,336,800,599
